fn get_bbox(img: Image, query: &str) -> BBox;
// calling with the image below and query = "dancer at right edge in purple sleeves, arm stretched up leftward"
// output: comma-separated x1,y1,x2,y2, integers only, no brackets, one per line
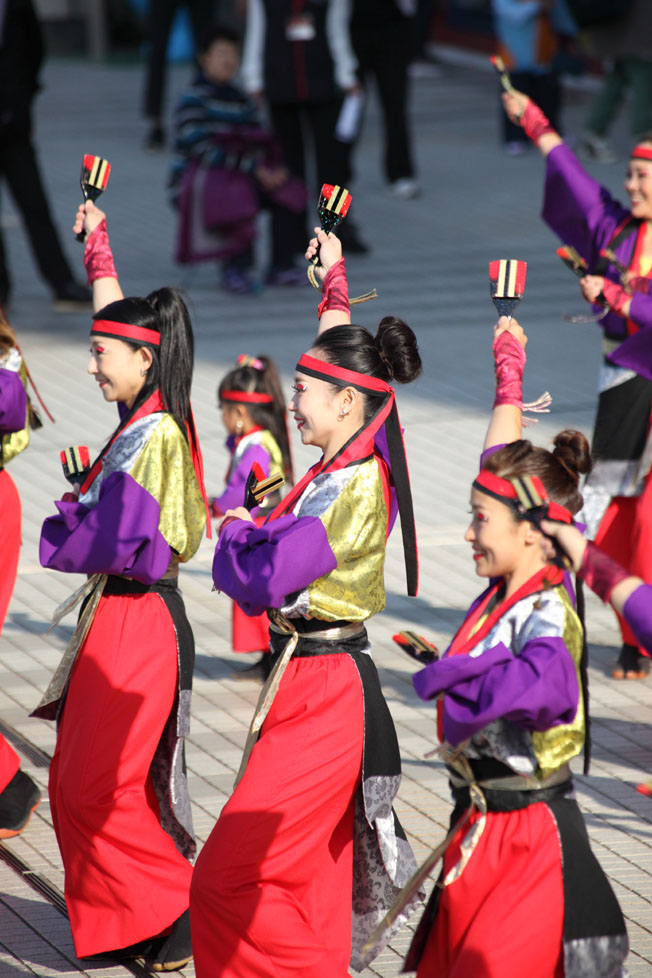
503,92,652,679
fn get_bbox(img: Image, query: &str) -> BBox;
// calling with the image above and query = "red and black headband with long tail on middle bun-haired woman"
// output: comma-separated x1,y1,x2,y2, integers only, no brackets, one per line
296,353,419,597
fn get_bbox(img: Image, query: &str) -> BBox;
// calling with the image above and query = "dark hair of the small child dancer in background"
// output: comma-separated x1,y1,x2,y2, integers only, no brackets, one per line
217,355,294,482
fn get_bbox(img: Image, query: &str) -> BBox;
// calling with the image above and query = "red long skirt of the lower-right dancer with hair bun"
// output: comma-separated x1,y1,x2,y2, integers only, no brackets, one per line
417,803,564,978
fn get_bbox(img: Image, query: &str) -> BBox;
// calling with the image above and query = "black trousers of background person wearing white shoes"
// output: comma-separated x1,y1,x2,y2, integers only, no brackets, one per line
351,16,414,183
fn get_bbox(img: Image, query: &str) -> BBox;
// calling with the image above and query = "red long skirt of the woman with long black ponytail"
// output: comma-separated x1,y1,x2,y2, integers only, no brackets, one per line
50,593,192,957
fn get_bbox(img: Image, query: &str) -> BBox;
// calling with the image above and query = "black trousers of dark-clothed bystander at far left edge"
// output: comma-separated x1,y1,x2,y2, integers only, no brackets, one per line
0,126,73,300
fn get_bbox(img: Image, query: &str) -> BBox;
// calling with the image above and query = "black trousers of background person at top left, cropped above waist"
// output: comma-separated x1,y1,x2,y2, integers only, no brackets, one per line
144,0,215,119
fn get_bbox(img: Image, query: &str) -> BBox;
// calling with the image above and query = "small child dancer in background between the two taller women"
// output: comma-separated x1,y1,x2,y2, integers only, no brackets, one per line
211,355,292,678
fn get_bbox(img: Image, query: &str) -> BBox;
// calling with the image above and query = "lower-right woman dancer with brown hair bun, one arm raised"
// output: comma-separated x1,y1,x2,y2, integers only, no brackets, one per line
406,319,628,978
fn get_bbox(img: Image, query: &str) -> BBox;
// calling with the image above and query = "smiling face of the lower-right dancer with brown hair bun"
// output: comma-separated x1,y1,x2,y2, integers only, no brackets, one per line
464,489,534,580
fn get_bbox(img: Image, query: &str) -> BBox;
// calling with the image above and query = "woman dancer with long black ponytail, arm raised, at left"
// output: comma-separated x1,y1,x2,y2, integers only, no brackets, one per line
35,202,207,971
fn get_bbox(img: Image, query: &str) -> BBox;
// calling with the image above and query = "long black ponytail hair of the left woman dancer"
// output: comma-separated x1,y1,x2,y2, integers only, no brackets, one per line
93,288,195,435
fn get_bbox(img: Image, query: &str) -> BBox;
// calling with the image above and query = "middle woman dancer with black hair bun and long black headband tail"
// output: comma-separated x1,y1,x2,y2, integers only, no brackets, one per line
191,231,421,978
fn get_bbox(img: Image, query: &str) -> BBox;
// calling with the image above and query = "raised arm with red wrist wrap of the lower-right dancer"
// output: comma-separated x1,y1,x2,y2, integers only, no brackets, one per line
483,316,527,452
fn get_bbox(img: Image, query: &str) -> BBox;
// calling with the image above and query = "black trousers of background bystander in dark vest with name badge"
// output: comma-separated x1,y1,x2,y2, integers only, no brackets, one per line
269,98,351,255
